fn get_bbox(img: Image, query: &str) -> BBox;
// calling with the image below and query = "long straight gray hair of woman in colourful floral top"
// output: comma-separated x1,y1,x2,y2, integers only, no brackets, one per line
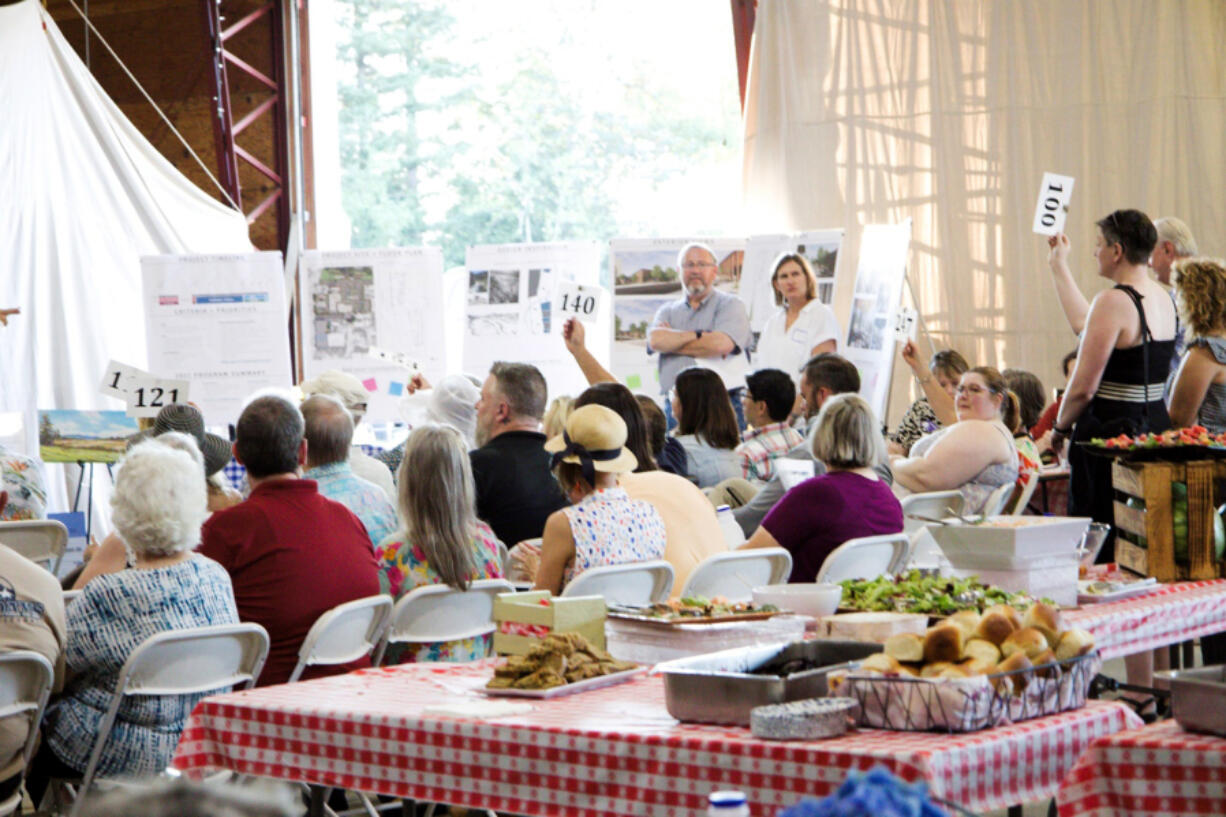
397,423,477,590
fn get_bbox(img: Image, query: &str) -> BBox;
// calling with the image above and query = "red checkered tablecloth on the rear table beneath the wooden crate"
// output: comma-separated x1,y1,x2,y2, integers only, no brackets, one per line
1064,579,1226,657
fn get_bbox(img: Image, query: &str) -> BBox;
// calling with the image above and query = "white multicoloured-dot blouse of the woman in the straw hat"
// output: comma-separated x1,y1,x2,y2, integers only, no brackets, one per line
562,488,664,583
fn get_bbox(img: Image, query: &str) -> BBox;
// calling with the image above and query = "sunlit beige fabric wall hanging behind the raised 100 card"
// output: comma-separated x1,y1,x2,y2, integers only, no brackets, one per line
744,0,1226,421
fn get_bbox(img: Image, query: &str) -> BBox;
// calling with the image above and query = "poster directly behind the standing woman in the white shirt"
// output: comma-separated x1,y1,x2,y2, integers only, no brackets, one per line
741,229,847,332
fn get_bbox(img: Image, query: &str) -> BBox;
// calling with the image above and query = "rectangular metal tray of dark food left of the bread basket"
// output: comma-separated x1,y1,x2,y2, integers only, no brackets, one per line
655,640,881,726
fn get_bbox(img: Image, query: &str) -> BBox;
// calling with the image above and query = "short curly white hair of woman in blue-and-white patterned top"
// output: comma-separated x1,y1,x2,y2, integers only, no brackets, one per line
110,439,208,556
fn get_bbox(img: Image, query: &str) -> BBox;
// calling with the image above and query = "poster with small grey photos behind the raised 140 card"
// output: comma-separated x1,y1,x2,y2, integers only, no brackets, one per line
463,236,608,399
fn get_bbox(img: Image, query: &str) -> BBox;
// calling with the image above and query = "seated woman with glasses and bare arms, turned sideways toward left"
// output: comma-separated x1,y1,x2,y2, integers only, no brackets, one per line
890,366,1019,514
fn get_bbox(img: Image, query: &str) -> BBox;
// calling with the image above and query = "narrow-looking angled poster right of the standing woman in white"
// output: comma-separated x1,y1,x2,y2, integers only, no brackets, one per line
840,218,911,417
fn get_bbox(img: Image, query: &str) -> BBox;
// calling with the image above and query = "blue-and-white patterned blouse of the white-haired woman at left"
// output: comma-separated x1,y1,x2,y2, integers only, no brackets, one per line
43,553,238,777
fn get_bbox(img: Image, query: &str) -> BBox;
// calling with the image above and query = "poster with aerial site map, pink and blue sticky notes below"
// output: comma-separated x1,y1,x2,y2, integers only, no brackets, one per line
298,247,446,422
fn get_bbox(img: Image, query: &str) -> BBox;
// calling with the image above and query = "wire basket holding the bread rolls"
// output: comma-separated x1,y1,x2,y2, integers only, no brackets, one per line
830,650,1102,732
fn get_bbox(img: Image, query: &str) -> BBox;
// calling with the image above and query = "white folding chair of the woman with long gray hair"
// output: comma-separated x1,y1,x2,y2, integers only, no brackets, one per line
374,579,515,666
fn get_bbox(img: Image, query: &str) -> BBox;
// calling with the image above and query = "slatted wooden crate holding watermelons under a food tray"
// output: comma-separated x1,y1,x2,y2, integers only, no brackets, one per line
1111,460,1226,581
